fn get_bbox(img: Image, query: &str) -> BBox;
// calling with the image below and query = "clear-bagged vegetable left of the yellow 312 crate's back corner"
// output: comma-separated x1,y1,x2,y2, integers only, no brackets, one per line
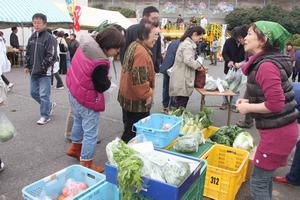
173,134,199,153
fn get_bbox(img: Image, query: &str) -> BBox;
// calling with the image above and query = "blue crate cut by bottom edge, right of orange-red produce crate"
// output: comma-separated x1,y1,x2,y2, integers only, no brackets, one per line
78,182,120,200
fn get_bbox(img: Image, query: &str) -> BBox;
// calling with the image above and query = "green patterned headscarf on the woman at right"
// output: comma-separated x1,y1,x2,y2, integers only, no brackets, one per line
255,21,290,51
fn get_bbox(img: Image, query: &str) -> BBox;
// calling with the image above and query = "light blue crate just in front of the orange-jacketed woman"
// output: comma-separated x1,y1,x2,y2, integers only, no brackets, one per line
133,114,182,148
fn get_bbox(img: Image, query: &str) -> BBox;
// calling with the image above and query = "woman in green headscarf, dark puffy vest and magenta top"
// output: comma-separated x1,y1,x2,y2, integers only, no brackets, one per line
237,21,298,200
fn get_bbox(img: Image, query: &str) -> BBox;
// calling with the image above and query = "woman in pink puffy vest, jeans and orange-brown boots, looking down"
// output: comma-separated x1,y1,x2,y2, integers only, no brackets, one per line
66,28,125,172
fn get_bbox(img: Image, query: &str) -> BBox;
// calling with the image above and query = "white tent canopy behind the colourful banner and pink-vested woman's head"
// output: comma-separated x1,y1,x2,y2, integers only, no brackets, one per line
55,3,133,29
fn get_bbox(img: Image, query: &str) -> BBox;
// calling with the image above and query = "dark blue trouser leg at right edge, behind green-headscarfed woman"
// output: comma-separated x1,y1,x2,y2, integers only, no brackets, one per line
286,140,300,185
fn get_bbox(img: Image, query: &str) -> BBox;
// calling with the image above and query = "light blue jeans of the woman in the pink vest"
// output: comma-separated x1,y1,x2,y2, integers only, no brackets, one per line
69,94,100,161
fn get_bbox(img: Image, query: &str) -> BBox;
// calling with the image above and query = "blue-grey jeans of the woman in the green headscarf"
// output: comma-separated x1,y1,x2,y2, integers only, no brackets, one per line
250,166,275,200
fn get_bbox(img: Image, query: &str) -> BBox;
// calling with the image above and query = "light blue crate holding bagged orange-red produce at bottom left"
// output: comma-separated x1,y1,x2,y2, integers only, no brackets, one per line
22,165,105,200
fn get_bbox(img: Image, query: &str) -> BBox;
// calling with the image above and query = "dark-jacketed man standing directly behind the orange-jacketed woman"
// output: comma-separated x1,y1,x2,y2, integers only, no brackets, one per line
120,6,161,73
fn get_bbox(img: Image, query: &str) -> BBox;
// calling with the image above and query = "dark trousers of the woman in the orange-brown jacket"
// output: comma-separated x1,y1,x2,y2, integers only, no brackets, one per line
121,108,150,143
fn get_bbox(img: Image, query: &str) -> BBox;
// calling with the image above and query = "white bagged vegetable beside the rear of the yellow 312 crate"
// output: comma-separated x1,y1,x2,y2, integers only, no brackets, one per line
232,132,254,151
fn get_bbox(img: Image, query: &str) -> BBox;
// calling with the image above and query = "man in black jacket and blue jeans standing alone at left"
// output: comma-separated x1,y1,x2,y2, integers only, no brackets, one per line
24,13,57,125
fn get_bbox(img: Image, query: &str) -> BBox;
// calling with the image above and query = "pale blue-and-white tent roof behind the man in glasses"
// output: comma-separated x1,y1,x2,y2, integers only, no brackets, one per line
0,0,72,28
